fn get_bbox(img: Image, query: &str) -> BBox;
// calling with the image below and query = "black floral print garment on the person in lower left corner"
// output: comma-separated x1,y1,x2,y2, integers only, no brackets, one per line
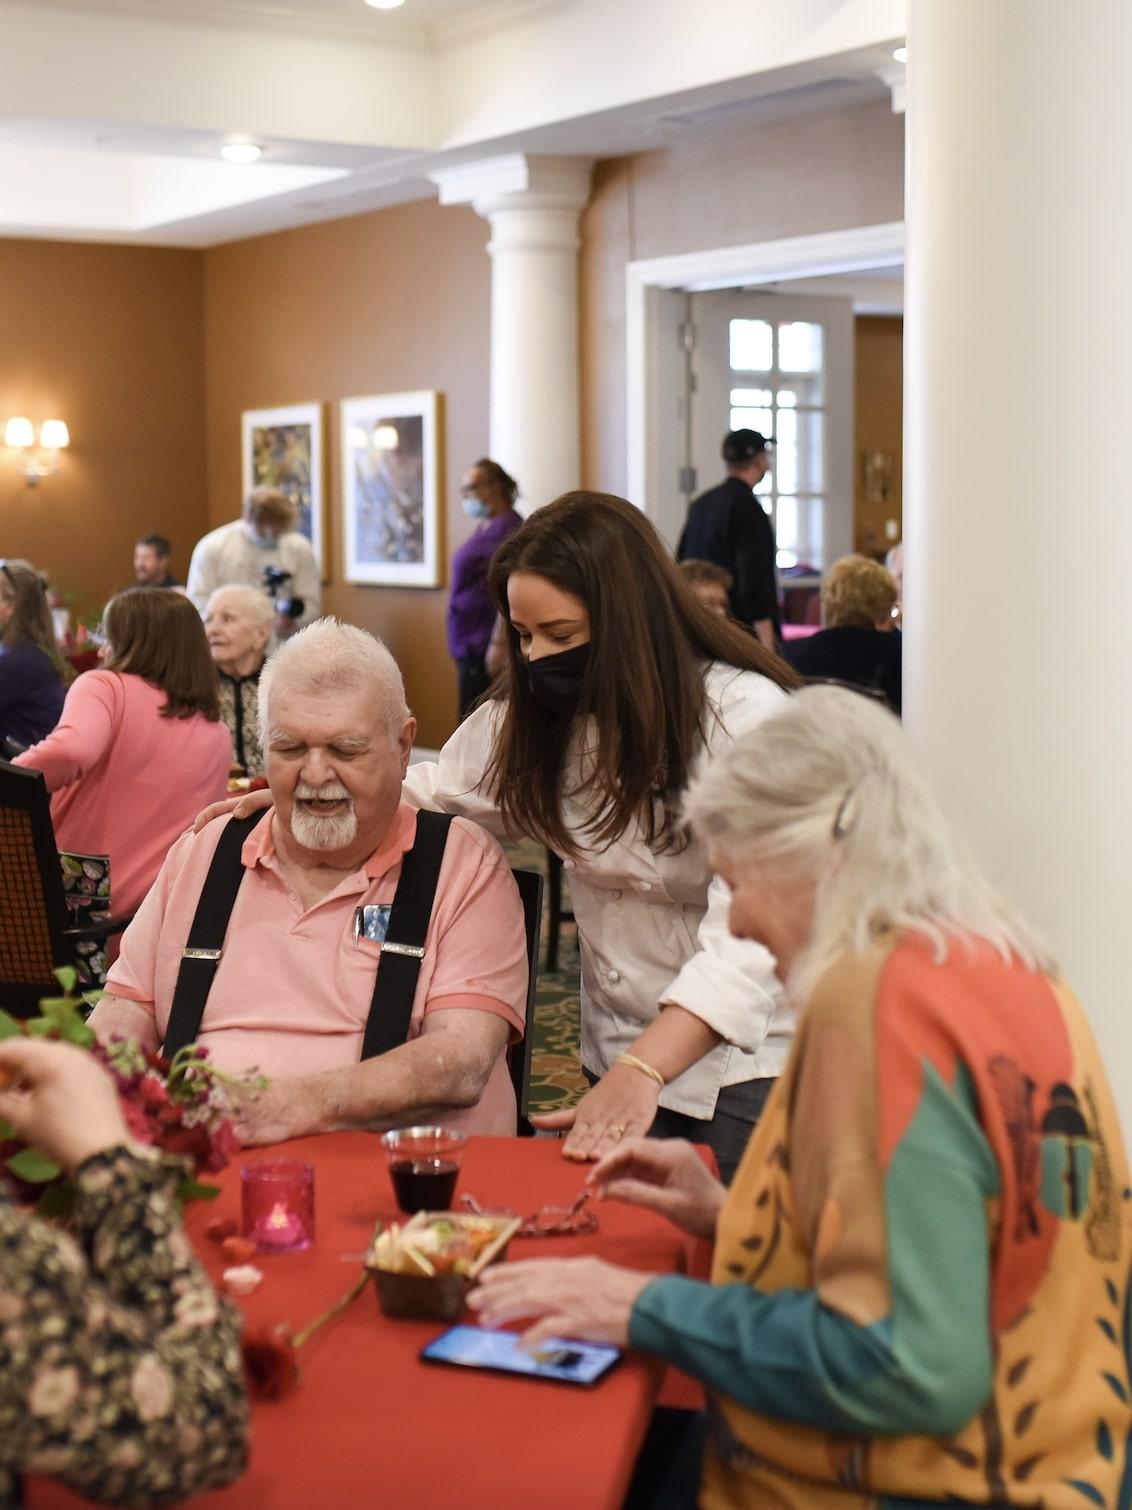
0,1148,248,1510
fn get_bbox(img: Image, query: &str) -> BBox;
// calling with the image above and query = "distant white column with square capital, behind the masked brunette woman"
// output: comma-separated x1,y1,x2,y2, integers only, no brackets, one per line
433,153,592,512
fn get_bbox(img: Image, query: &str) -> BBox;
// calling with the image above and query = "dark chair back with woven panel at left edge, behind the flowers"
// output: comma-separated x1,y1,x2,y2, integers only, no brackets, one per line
0,761,74,1018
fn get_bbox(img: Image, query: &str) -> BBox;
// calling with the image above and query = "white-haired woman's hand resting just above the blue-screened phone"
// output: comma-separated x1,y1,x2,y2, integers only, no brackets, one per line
468,1258,657,1348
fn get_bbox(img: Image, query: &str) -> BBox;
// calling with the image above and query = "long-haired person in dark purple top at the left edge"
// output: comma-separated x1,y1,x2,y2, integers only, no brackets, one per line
0,560,66,755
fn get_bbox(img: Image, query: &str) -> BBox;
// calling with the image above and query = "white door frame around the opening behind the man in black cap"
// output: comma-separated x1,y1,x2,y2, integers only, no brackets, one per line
625,220,904,515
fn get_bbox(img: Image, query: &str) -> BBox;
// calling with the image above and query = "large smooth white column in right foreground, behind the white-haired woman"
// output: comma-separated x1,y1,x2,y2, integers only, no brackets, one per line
904,0,1132,1133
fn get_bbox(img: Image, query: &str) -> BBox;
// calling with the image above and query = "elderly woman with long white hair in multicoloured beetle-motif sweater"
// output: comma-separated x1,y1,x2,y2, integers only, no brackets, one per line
471,687,1132,1510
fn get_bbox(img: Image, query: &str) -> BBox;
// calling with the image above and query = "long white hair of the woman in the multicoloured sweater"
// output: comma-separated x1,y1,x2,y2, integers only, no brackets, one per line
684,687,1057,1001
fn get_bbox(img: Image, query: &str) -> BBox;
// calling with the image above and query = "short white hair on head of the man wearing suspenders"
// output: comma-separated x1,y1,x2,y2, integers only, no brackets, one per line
258,619,409,749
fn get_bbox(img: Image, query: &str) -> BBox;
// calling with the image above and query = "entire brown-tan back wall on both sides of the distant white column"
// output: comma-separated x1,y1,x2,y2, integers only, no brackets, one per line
0,103,903,744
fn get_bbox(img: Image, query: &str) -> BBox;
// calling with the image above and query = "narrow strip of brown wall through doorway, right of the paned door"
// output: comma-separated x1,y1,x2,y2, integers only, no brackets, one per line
853,316,904,556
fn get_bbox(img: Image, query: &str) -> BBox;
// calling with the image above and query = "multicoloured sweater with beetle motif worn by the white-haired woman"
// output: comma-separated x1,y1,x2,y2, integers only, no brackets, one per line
631,936,1132,1510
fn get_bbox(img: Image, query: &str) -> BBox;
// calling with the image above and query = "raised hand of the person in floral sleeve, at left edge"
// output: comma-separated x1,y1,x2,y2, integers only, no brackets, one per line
0,1037,130,1173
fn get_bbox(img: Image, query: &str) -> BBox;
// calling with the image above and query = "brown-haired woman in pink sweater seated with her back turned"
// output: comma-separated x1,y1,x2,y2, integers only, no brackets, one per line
15,587,232,918
